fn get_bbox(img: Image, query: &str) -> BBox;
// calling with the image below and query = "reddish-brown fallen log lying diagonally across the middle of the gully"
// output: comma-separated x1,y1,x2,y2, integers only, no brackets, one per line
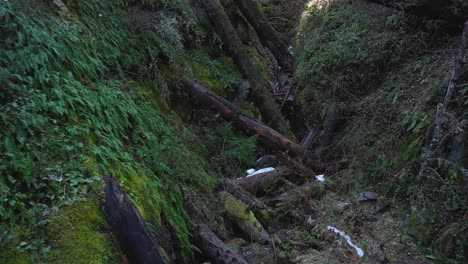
182,77,301,155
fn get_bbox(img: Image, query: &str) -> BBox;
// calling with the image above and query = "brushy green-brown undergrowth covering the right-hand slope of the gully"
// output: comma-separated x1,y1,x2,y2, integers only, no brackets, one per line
295,3,468,263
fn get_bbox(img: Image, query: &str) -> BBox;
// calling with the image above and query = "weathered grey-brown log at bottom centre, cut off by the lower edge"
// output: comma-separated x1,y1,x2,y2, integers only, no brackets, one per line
194,224,247,264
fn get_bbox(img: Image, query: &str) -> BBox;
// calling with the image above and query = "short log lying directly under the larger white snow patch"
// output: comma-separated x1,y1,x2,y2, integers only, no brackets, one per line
235,167,289,195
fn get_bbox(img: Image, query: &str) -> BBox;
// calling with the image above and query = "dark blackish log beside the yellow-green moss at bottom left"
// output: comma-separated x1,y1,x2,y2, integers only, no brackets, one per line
104,175,166,264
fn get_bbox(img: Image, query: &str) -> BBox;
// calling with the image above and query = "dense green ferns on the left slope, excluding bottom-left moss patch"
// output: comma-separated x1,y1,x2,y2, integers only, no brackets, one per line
0,1,213,257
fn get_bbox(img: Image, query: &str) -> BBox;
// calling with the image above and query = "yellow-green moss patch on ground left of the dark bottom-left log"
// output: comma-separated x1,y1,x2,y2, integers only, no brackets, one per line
47,185,122,263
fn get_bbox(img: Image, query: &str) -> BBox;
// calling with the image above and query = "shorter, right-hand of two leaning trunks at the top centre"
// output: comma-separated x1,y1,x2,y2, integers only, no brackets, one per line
236,0,292,71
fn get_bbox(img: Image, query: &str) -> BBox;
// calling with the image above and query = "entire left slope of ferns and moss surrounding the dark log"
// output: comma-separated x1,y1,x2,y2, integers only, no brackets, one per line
0,0,255,263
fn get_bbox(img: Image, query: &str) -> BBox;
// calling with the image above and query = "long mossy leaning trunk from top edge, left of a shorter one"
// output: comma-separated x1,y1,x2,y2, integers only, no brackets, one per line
198,0,290,134
